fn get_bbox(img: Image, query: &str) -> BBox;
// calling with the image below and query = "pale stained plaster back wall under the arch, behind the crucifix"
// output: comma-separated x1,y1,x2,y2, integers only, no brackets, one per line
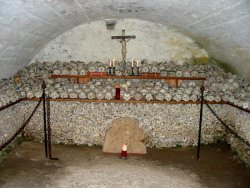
30,19,208,63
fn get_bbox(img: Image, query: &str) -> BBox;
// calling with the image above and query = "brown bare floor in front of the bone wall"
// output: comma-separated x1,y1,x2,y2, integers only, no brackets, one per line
0,142,250,188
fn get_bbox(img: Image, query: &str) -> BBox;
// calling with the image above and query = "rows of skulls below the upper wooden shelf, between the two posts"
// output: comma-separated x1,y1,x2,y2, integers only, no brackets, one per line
47,79,200,101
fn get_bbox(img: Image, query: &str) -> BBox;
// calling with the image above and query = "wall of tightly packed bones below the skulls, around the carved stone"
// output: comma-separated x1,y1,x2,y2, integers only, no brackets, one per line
0,101,250,162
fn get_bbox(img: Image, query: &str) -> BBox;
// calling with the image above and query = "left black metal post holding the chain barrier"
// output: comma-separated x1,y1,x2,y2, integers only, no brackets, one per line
42,81,48,158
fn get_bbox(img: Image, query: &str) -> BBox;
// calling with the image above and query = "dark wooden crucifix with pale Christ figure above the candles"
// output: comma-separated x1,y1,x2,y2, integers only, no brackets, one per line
111,30,135,70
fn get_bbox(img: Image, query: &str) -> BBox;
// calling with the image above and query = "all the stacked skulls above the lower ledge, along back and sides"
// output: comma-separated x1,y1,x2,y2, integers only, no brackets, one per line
0,60,250,109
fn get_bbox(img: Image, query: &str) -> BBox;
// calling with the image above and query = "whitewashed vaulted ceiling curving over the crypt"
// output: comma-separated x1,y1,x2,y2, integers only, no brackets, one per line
0,0,250,81
